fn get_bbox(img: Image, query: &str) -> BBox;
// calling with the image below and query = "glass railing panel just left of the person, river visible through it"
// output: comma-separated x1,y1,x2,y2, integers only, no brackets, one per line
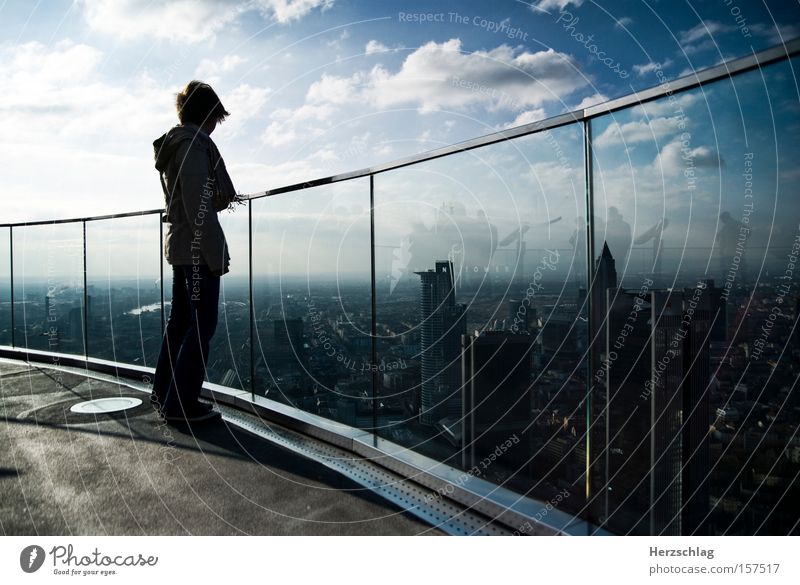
86,214,161,368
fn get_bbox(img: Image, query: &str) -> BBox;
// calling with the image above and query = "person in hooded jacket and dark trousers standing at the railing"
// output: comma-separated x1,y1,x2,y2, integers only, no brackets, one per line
150,81,239,424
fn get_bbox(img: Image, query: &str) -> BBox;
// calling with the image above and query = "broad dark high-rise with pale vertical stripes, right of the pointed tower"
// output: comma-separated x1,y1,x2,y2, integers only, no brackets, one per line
603,287,710,535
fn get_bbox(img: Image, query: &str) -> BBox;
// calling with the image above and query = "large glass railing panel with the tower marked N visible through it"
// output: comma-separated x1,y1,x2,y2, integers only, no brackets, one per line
375,124,588,510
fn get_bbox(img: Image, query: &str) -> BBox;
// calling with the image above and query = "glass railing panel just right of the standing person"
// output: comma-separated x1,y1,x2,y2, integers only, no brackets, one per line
252,179,372,428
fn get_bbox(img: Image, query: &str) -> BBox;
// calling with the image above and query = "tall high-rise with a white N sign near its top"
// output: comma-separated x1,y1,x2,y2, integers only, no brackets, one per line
415,260,466,425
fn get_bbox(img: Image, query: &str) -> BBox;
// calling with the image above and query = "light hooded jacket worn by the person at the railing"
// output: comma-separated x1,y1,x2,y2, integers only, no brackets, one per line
153,124,236,276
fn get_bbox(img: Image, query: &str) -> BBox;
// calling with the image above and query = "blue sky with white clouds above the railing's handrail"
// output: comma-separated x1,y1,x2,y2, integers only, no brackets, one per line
0,0,800,221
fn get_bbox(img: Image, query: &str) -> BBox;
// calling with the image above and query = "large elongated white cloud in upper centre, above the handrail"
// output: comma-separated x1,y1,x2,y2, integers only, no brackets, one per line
256,39,587,145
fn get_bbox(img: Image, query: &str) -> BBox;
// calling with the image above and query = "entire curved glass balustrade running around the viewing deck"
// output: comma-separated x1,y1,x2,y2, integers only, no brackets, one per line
0,45,800,535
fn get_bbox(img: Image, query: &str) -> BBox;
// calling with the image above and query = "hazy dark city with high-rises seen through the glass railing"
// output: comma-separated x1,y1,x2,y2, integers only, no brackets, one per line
0,233,800,534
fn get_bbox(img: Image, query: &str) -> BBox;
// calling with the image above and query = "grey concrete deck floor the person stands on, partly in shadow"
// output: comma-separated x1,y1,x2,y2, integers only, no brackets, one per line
0,361,442,535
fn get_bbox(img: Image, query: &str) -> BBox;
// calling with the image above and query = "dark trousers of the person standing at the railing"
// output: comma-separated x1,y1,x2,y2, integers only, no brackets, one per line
150,265,220,414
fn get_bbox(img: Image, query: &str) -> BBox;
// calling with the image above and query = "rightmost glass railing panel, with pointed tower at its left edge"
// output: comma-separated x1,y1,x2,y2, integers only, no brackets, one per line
591,61,800,534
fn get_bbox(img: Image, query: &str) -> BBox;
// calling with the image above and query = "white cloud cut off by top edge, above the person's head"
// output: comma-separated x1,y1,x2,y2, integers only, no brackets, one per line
78,0,333,43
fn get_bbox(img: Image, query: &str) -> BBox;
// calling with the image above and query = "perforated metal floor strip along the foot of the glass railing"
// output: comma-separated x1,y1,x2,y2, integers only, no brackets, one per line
217,404,511,536
